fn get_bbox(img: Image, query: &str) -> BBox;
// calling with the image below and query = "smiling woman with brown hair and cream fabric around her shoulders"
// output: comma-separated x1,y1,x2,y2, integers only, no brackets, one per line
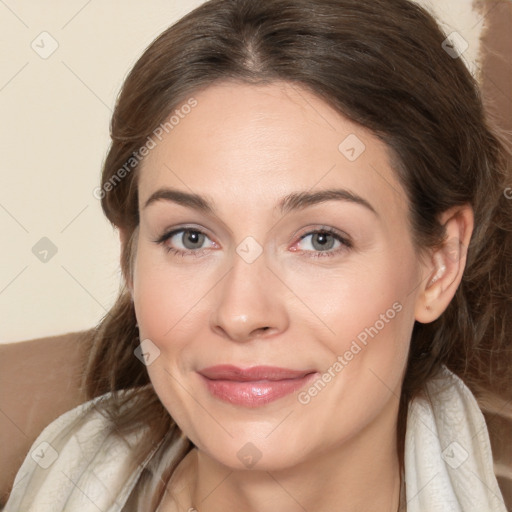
6,0,512,512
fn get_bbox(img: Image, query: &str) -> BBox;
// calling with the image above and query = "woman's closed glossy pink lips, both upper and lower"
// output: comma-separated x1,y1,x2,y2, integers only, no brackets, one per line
198,365,318,407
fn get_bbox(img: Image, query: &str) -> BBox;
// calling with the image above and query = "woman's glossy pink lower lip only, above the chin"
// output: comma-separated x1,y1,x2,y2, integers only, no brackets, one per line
200,373,318,407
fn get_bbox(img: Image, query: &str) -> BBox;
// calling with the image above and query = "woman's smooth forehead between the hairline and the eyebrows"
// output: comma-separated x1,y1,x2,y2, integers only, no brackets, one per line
139,82,405,221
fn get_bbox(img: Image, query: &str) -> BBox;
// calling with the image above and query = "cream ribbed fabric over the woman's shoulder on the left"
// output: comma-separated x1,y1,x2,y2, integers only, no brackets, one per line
3,393,148,512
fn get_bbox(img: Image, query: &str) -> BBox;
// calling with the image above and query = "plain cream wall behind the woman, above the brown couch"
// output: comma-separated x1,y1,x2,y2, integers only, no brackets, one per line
0,0,486,343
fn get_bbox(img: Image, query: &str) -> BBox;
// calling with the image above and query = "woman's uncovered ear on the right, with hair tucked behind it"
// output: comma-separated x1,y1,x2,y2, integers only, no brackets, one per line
415,205,474,323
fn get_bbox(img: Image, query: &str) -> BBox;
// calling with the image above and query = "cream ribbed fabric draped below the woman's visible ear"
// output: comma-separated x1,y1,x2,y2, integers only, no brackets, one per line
404,366,507,512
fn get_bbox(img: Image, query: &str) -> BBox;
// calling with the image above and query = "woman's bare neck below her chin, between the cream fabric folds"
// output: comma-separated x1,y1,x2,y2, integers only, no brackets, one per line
162,403,400,512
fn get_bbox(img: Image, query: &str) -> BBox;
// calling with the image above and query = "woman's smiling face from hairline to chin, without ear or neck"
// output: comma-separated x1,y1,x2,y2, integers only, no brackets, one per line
133,82,424,469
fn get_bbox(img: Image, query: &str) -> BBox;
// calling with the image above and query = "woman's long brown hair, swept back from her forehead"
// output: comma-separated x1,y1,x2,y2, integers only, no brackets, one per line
85,0,512,510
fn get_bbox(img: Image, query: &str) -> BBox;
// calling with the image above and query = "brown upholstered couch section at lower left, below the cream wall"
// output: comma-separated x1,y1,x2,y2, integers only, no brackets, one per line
0,331,87,507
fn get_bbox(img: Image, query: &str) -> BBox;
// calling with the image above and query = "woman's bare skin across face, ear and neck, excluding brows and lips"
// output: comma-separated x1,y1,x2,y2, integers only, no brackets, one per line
121,82,473,512
